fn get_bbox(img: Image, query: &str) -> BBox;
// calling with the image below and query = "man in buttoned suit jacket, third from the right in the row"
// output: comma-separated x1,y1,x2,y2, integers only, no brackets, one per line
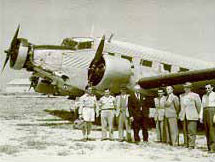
164,86,179,146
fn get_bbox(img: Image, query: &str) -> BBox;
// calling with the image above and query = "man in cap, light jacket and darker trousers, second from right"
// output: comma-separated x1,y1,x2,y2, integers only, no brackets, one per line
179,82,201,149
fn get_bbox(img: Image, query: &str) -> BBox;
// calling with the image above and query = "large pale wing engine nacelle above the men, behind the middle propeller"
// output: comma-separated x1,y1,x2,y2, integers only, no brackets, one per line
88,55,132,93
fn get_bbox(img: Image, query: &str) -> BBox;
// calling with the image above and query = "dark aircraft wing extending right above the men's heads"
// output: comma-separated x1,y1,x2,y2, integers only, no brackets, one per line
138,68,215,95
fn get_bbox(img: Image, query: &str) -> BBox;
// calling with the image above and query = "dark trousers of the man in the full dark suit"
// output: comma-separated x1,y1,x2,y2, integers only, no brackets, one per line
132,118,149,142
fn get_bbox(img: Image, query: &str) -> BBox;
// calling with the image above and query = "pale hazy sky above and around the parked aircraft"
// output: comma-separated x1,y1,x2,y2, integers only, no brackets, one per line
0,0,215,88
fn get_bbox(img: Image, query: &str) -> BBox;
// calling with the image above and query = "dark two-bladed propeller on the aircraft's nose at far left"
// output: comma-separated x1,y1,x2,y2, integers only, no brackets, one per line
2,25,20,72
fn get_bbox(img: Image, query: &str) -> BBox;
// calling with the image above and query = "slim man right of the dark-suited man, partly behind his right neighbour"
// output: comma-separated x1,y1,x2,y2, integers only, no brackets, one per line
154,89,166,142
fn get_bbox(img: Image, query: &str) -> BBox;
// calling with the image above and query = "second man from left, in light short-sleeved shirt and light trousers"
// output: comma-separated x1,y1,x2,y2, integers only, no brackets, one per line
99,89,116,140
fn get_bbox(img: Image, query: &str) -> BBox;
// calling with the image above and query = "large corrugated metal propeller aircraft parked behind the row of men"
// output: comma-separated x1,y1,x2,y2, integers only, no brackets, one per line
2,26,215,98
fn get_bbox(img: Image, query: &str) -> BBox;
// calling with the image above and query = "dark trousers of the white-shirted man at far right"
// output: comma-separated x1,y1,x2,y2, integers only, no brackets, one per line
203,107,215,152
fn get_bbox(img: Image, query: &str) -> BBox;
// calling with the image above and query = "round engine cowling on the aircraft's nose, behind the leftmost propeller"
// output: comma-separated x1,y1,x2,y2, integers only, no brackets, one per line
10,38,29,70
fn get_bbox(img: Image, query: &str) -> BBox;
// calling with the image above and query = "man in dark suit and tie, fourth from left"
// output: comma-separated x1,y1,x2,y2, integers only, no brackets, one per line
128,85,149,143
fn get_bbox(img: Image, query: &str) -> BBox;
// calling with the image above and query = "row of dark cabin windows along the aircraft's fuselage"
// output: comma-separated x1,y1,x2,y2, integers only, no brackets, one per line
109,53,189,72
